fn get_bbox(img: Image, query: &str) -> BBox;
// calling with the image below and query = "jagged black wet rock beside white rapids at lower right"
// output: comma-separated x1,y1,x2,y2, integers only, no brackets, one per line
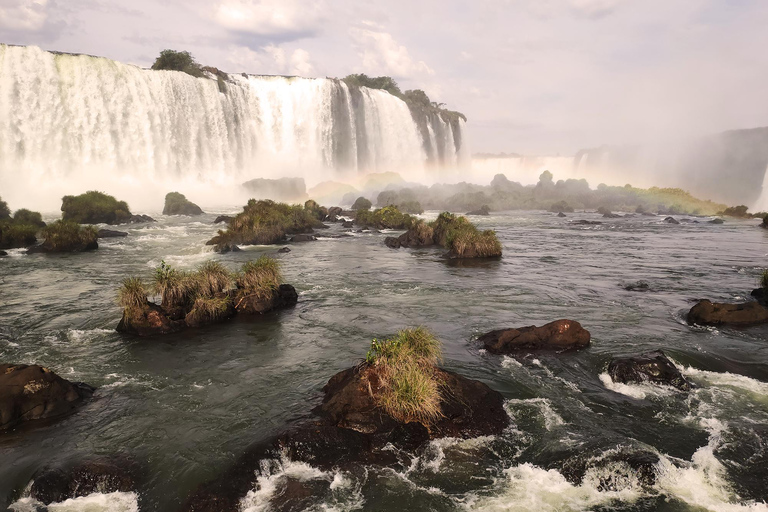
608,350,691,391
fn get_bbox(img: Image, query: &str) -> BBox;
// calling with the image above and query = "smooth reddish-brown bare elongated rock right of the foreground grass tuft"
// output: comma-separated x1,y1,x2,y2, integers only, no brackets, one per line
478,319,591,354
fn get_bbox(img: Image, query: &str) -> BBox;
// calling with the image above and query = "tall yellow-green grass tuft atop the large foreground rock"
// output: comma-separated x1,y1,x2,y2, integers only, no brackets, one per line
366,327,442,425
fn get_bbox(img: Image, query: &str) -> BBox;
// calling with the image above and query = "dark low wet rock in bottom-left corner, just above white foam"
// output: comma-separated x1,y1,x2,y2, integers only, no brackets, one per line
30,455,142,504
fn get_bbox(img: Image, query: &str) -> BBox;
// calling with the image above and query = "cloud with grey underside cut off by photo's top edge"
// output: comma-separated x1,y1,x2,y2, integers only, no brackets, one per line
214,0,325,40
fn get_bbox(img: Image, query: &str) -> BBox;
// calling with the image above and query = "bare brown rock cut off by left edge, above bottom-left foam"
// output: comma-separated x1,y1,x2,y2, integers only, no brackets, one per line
0,364,94,431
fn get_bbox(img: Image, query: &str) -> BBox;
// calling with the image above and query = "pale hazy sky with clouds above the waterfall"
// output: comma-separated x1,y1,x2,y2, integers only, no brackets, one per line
0,0,768,155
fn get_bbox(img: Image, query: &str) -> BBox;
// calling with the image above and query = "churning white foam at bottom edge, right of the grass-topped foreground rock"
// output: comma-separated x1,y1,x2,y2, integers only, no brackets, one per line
467,463,641,512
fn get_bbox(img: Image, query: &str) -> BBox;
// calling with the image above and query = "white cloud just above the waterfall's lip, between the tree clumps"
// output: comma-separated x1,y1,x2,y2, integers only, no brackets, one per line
227,45,315,77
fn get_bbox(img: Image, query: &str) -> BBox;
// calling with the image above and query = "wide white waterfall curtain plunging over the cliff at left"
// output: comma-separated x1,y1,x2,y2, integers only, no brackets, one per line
0,45,469,211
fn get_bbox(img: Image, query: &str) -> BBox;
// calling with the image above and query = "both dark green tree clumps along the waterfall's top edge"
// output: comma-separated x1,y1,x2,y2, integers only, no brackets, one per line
152,49,467,125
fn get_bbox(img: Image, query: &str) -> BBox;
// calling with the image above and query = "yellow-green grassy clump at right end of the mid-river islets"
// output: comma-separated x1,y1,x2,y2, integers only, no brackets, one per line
431,212,501,258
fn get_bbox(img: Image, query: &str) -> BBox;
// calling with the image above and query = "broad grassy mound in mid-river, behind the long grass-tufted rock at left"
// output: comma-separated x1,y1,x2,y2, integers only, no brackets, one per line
208,199,322,252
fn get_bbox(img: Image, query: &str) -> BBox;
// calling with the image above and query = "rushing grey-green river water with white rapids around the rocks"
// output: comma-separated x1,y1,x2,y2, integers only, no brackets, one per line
0,212,768,512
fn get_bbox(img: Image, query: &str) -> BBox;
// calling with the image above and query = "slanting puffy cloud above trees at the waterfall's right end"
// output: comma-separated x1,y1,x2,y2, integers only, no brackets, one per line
349,23,435,78
